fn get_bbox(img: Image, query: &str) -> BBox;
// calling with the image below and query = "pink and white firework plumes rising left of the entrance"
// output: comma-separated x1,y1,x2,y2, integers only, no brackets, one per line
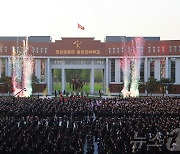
12,40,33,97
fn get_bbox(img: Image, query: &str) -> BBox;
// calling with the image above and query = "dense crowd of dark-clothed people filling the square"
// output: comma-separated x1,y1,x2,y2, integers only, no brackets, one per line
0,96,180,154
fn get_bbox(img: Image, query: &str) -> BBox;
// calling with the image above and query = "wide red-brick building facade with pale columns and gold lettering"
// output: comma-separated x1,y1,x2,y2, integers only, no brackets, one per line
0,36,180,94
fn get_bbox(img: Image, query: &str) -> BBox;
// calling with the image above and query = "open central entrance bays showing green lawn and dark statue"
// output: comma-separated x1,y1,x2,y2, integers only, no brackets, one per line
52,69,104,93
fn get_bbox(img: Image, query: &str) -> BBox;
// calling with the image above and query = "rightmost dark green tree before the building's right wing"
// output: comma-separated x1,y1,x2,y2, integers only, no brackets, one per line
159,78,172,96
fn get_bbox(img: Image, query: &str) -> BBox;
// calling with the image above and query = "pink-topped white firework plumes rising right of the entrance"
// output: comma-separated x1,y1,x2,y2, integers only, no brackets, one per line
121,37,144,98
